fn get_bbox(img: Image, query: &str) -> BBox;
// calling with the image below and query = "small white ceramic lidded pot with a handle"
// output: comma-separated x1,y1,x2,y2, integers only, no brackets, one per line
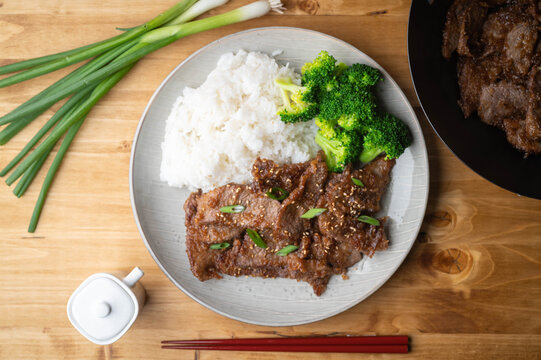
68,267,146,345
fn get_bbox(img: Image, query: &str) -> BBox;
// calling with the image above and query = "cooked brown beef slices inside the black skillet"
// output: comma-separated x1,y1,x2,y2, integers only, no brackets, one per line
442,0,541,155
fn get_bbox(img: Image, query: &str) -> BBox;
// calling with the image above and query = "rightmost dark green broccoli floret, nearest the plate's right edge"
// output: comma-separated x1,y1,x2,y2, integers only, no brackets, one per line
360,114,412,163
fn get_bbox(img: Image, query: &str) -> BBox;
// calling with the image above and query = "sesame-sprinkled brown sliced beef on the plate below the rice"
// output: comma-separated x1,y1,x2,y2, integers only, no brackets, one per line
184,152,394,295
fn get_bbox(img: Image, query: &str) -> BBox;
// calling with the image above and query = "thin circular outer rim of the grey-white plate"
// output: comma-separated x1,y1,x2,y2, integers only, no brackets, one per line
128,26,430,326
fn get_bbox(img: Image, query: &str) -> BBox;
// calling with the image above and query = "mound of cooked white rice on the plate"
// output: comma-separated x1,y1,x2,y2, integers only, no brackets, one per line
160,50,318,191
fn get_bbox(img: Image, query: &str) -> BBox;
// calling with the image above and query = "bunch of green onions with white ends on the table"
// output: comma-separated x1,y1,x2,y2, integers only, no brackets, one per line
0,0,283,232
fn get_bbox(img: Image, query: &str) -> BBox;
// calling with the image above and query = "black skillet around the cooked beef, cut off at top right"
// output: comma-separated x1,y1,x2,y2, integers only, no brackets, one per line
408,0,541,199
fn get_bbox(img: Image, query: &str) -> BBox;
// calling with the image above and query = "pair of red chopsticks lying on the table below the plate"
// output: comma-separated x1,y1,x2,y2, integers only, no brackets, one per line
162,336,409,353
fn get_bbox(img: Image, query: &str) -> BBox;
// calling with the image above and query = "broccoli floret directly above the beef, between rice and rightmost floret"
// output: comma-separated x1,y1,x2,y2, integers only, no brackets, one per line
316,130,362,172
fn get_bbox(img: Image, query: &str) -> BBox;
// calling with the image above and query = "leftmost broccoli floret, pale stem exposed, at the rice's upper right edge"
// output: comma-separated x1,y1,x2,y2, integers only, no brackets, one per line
274,78,318,123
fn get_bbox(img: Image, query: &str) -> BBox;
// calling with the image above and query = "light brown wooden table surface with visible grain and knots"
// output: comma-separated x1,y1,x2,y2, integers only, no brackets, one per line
0,0,541,359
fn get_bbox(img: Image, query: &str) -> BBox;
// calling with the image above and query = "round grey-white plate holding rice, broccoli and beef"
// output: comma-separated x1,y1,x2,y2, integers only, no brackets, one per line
130,27,428,326
